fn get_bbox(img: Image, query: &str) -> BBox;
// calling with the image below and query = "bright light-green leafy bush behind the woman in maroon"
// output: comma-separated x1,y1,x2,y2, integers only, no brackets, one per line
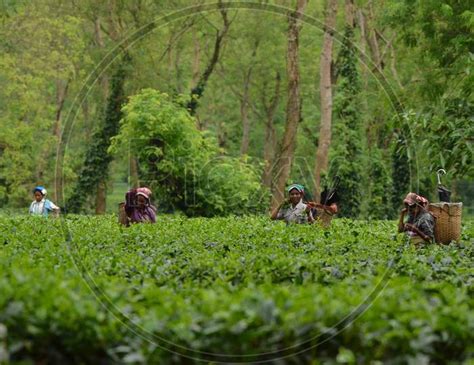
111,89,265,216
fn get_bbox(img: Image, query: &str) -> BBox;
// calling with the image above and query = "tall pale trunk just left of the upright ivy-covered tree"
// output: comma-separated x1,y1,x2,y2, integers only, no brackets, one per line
314,0,337,201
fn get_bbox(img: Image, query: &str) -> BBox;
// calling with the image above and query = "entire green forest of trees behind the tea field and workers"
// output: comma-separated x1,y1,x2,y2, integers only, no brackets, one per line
0,0,474,218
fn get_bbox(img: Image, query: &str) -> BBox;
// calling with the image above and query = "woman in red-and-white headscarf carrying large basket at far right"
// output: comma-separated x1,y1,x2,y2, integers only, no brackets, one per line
398,193,435,243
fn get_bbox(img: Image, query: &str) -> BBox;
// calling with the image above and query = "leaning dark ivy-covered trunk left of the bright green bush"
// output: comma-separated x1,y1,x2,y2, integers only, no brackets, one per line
66,65,126,213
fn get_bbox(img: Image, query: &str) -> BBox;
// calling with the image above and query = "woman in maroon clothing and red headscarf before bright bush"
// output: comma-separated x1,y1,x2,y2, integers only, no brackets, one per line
125,187,156,225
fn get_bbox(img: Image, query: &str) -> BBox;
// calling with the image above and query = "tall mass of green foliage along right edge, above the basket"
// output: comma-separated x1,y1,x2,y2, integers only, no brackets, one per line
379,0,474,206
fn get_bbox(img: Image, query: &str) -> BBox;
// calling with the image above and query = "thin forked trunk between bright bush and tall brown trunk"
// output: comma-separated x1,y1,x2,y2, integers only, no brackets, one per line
262,72,280,189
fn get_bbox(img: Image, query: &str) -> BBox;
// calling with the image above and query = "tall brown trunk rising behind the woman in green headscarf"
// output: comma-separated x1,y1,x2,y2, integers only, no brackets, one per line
271,0,306,210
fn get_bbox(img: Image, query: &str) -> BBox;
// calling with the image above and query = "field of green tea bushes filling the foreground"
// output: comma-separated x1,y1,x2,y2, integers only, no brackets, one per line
0,215,474,364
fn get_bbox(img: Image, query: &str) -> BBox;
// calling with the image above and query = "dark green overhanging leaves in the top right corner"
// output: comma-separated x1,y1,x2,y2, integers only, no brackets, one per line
382,0,474,101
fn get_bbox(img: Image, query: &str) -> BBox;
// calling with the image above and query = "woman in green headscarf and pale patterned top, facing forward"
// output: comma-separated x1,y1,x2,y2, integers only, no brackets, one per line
270,184,314,224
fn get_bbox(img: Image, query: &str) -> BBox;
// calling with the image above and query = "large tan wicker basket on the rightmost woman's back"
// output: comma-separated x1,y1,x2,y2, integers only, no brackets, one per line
428,203,462,243
